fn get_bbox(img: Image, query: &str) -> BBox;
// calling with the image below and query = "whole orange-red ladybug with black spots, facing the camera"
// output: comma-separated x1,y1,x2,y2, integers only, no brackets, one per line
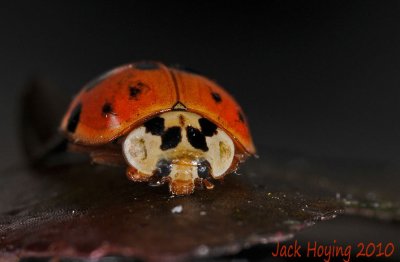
60,62,255,195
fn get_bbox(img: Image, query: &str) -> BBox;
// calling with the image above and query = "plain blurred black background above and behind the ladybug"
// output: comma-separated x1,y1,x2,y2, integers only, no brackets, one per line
0,1,400,166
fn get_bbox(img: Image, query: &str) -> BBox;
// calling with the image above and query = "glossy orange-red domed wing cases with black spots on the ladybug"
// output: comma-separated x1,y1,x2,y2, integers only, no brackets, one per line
61,62,255,154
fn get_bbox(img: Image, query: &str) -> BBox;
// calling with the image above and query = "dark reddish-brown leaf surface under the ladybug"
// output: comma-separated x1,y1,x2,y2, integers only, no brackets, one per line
0,159,343,260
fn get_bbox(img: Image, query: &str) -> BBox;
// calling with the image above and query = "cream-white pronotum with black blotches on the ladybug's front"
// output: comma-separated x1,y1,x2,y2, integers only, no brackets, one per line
123,111,235,181
